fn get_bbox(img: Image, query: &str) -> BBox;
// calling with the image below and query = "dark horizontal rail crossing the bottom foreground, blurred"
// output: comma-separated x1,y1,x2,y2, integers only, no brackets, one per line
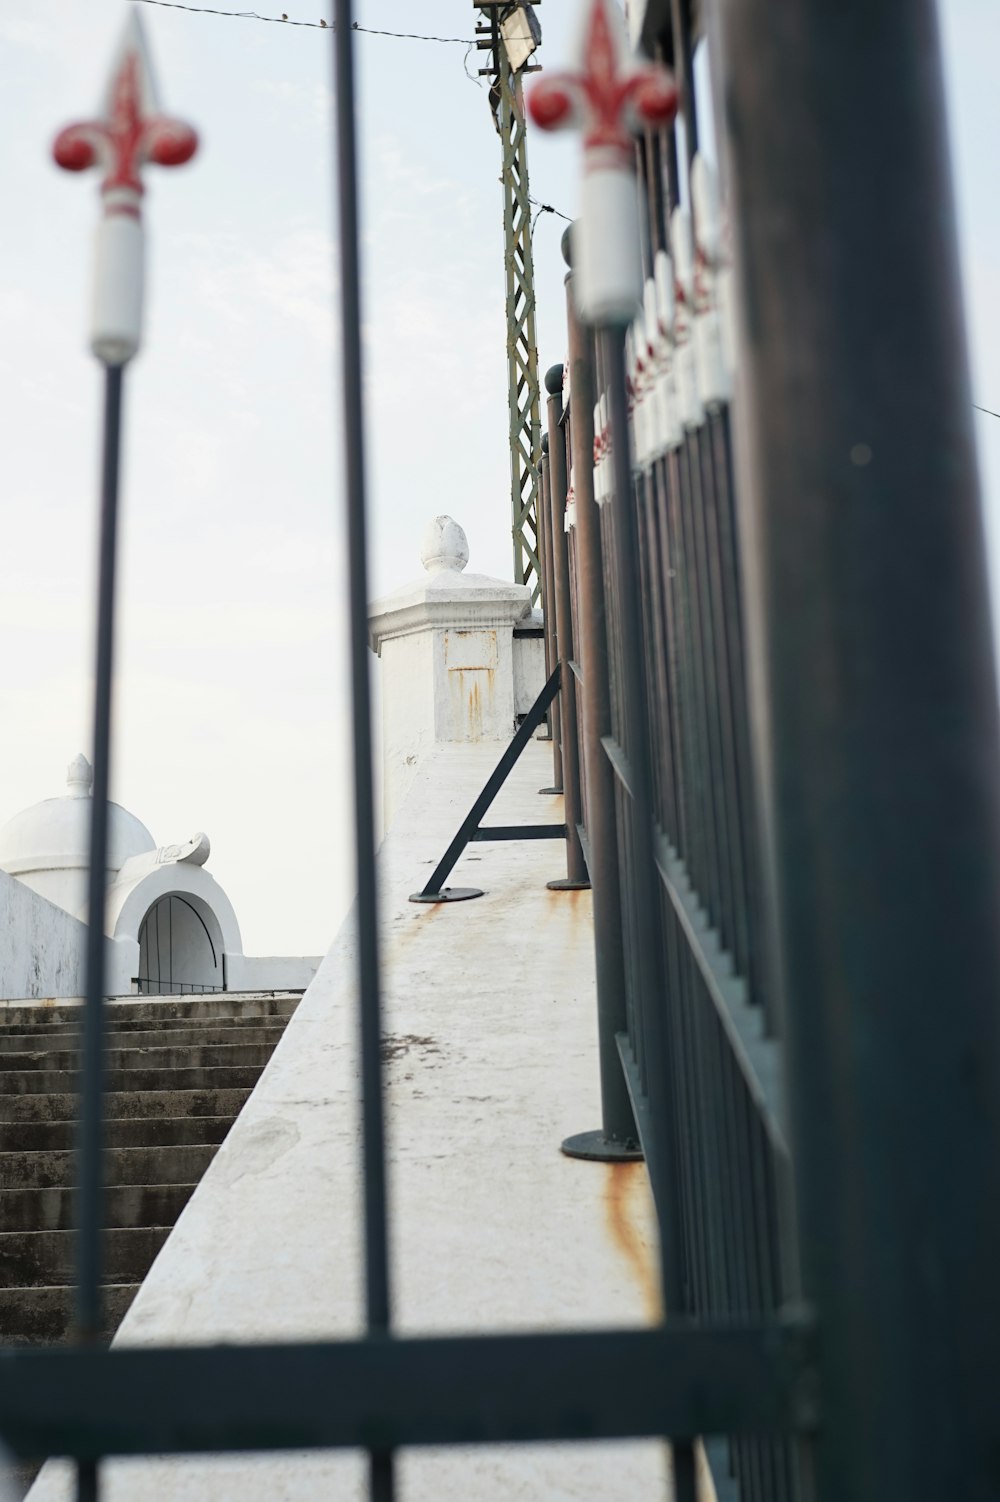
0,1317,815,1463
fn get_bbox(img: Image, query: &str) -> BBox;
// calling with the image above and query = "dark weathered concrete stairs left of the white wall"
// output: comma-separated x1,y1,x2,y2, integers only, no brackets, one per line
0,993,299,1346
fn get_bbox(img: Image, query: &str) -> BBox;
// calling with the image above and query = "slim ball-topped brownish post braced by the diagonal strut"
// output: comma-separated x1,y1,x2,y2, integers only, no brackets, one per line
545,365,590,891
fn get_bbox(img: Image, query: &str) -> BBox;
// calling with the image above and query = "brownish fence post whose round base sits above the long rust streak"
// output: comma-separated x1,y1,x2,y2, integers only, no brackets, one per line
563,249,633,1161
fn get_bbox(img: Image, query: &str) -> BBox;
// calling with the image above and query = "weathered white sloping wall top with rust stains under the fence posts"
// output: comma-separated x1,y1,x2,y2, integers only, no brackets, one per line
32,745,667,1502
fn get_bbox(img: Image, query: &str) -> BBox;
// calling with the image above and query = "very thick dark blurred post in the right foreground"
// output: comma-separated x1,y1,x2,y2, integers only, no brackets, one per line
718,0,1000,1502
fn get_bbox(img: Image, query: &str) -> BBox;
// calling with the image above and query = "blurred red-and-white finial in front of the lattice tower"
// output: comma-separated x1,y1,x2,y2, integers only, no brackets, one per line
529,0,677,324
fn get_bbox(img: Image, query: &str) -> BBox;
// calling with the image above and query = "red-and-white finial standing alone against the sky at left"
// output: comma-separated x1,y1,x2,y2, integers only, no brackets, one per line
53,11,198,365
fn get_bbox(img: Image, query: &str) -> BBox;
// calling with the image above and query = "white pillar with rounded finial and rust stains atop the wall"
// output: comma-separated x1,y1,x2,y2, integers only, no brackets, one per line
368,517,542,829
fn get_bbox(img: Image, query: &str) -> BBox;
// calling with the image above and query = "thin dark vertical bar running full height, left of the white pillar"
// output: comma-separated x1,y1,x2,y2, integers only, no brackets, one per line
333,11,395,1502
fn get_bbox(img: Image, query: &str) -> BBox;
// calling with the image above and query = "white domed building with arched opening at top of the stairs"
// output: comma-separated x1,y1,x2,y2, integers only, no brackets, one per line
0,756,318,999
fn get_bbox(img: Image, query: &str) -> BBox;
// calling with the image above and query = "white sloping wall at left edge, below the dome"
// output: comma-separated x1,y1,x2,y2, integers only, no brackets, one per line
0,871,87,999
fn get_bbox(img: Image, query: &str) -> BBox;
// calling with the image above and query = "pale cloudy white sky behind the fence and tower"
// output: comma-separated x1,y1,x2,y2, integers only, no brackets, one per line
0,0,1000,954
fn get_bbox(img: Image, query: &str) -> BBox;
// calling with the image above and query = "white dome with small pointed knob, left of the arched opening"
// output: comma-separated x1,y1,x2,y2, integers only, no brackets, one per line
0,757,156,876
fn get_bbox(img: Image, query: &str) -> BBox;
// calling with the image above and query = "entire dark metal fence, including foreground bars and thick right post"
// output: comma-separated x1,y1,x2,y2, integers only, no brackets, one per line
0,0,1000,1502
